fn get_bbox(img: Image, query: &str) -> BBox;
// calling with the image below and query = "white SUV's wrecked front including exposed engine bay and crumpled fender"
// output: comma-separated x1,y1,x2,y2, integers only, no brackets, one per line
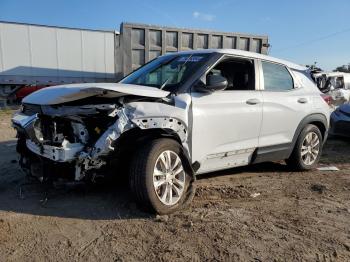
12,89,188,181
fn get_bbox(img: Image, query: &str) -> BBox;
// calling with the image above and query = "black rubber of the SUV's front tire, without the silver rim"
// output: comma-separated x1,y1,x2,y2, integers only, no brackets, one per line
129,138,194,215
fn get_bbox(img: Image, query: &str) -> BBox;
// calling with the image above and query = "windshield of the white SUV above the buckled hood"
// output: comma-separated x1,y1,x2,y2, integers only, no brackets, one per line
121,54,209,92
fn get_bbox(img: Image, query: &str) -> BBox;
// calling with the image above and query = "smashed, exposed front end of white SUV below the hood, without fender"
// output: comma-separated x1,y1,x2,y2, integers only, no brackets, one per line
12,104,132,180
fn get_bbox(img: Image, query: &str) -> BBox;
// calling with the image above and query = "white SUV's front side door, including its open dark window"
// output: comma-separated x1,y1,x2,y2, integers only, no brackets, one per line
192,57,262,173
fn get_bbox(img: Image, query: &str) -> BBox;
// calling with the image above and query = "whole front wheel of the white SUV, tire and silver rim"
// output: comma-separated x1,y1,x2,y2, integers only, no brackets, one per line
129,138,194,215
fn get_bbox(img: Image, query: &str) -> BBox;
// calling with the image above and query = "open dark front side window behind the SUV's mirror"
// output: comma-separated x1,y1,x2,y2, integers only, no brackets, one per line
207,58,255,90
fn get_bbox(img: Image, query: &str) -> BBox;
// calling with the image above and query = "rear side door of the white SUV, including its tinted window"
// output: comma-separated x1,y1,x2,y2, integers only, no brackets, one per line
259,61,312,148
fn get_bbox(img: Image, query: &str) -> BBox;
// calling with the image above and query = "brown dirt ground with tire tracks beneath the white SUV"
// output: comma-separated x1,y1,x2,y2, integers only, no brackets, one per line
0,109,350,261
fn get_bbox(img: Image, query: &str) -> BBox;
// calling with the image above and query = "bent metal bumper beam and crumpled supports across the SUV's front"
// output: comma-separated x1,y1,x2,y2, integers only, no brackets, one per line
12,108,134,180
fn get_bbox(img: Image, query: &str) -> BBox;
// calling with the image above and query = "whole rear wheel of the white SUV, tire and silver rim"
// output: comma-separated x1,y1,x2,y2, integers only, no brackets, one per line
286,124,323,171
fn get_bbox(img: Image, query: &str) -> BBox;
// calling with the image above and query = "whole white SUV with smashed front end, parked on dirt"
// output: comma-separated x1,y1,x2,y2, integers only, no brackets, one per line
13,49,329,214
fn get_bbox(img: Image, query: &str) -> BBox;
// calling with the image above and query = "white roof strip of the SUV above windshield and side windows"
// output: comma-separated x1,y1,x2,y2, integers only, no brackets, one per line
172,49,308,71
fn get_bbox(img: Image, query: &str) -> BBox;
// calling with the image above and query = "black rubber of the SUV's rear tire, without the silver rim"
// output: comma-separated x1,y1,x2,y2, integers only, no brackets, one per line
286,124,323,171
